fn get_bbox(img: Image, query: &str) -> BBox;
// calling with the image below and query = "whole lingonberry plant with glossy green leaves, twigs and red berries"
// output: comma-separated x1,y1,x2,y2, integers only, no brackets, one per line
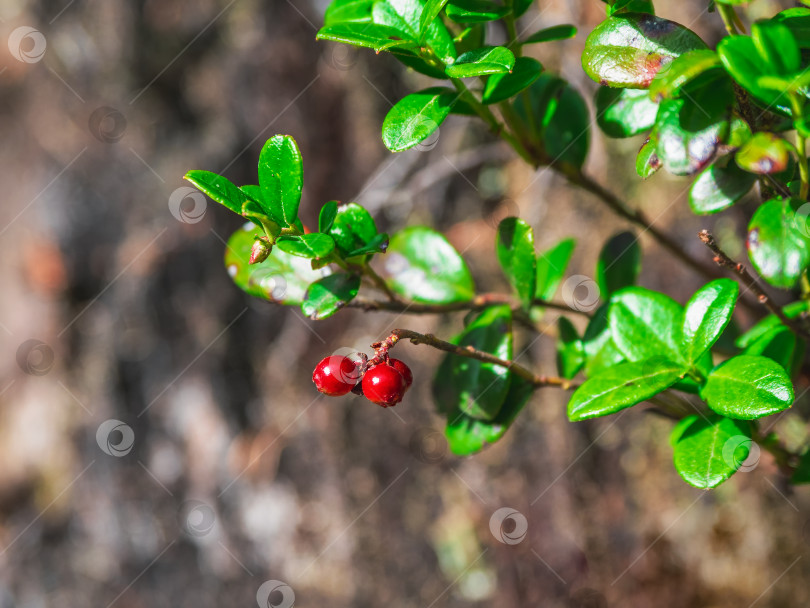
186,0,810,488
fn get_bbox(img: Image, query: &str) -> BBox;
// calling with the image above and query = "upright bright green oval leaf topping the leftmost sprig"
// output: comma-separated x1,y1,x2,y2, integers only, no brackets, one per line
259,135,304,226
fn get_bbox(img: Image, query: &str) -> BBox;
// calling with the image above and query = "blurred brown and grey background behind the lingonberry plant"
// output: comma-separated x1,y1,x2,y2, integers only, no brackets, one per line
0,0,810,608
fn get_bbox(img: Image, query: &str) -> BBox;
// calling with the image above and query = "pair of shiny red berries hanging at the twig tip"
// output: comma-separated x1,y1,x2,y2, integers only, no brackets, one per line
312,355,413,407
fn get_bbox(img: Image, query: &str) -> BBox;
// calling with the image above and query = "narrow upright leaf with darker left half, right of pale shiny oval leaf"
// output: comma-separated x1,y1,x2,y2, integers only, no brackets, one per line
495,217,537,309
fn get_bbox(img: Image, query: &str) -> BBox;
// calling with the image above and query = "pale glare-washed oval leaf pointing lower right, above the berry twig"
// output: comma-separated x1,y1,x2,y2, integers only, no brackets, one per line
385,226,475,304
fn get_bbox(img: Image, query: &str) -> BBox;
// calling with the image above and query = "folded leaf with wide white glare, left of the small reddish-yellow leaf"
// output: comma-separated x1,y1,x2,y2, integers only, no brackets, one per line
650,99,730,175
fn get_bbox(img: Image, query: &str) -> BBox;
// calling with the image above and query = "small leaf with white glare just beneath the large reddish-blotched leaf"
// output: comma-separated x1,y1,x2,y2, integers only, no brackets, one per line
596,87,658,137
